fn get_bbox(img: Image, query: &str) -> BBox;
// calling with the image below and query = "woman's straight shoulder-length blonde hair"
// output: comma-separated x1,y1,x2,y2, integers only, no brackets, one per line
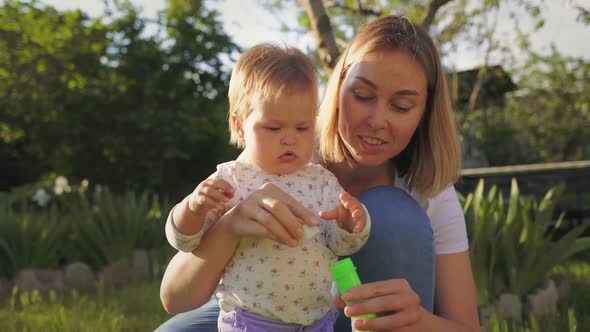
317,16,461,197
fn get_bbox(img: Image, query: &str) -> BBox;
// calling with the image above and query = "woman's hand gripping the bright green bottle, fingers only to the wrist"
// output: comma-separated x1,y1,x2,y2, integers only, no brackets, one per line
333,279,425,331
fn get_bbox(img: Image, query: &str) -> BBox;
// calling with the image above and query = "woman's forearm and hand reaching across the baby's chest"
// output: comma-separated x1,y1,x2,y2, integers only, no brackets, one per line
160,183,319,314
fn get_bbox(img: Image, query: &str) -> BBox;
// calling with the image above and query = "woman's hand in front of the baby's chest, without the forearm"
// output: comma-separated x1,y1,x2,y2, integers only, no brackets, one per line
225,183,319,247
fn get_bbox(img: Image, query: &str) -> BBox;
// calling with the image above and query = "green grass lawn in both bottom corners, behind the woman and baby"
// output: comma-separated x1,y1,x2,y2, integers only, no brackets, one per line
0,261,590,332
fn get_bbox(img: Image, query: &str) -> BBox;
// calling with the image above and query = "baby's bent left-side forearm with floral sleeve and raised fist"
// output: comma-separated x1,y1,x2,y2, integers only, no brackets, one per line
166,174,234,252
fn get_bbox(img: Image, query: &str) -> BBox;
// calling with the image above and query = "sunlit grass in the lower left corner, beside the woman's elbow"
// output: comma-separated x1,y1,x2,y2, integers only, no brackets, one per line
0,281,169,332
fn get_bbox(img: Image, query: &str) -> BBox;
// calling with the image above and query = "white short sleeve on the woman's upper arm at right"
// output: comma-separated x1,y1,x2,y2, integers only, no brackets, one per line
426,186,469,255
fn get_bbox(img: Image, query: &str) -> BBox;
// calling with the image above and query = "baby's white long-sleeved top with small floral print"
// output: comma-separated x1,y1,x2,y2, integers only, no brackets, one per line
166,161,371,325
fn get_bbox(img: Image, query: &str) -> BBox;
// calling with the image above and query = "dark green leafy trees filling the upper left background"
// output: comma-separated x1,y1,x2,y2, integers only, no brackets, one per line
0,0,237,194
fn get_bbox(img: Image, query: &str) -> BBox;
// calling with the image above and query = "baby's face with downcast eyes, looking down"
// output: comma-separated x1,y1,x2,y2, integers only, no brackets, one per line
241,91,316,174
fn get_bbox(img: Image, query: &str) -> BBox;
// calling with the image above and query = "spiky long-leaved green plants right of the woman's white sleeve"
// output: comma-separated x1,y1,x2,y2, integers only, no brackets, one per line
461,180,590,304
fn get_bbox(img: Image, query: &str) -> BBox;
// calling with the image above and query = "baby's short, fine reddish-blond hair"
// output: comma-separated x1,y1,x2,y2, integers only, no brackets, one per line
228,43,318,148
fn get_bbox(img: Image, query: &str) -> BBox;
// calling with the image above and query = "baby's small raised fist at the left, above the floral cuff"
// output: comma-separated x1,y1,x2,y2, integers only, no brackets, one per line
188,178,234,217
